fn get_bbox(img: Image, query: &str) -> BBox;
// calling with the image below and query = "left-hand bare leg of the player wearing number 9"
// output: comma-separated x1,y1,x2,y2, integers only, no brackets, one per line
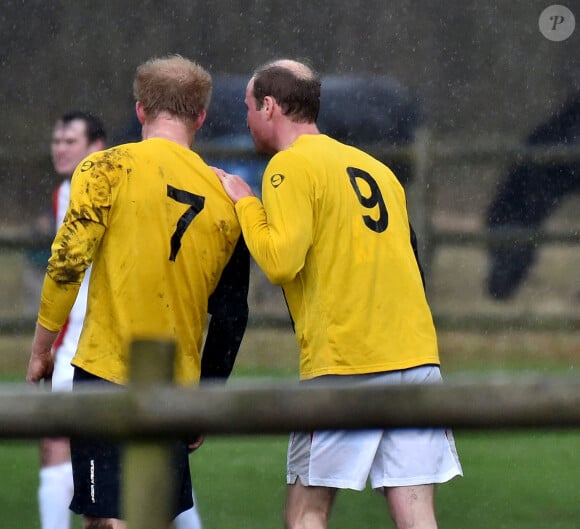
284,479,336,529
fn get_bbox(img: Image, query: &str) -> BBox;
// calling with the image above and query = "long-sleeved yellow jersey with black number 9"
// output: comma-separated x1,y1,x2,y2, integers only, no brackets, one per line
236,135,439,379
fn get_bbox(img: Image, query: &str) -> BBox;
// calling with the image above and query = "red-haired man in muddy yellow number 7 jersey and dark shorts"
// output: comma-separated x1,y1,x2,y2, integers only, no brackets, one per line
27,55,249,529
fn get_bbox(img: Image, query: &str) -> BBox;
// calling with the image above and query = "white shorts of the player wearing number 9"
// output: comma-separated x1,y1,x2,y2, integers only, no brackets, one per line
286,365,463,490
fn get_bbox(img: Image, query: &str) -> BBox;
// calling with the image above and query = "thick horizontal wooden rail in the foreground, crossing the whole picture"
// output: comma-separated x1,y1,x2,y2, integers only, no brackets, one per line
0,376,580,439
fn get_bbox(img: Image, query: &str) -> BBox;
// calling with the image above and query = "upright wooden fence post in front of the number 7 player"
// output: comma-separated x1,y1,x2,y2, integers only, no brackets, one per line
123,341,175,529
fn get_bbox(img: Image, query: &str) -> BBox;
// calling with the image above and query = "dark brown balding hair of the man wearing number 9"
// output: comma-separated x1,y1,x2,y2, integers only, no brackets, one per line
252,59,320,123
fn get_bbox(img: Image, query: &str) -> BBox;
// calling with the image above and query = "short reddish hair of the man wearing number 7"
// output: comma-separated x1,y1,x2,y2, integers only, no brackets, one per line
133,55,212,121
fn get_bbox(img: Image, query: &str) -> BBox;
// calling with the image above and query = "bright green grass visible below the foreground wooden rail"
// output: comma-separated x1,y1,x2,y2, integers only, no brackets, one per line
0,431,580,529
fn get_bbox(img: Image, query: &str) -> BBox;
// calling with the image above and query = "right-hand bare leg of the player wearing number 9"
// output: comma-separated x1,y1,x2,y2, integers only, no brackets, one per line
385,485,437,529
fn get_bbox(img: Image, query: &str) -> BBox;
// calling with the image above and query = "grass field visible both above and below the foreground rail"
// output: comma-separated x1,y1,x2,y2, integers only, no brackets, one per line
0,330,580,529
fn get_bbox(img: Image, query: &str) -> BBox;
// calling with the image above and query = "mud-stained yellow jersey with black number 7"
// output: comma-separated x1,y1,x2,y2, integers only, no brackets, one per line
39,139,247,383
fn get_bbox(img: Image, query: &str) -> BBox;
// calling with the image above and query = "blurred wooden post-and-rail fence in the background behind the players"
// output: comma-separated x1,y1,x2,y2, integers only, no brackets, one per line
0,138,580,333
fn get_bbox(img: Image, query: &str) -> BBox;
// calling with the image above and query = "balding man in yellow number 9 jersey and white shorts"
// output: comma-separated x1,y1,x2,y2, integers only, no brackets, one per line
214,60,462,529
